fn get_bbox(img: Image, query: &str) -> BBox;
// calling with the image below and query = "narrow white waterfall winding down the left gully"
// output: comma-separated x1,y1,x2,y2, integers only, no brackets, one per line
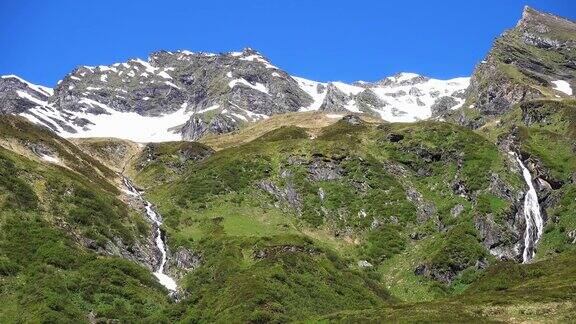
124,178,177,292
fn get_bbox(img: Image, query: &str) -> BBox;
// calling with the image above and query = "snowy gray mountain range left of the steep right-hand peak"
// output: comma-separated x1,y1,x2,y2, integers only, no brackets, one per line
0,49,468,142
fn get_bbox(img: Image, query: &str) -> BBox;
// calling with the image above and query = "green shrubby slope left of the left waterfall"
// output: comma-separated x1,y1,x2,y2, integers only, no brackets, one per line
0,117,168,322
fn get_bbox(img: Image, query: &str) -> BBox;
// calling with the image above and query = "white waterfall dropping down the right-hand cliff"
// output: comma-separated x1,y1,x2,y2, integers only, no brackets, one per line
514,154,544,263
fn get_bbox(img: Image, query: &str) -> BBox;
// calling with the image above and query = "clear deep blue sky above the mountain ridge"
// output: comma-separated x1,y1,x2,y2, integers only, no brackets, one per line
0,0,576,86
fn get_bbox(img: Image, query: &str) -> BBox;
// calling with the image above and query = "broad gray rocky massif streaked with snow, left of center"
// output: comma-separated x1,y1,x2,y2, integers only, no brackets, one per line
50,49,312,139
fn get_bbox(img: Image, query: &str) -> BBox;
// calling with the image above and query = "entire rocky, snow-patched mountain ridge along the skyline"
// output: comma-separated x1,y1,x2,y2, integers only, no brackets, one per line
0,7,576,142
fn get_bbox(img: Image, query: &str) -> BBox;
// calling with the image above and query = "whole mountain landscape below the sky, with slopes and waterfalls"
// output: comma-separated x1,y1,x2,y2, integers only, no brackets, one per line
0,8,576,323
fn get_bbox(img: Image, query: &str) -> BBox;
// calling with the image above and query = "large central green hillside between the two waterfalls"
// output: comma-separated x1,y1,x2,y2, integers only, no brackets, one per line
127,117,536,320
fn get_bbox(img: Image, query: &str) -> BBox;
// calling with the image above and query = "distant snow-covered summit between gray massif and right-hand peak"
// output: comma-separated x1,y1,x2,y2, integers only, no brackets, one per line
294,73,469,122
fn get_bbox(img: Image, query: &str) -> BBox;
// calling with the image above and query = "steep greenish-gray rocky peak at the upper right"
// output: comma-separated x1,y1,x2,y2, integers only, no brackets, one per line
460,7,576,127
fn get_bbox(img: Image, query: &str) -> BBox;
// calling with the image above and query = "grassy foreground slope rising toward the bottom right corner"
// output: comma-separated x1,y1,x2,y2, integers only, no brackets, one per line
314,250,576,323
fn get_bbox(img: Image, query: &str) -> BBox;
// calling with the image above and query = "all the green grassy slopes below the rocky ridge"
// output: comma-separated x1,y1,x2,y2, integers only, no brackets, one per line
0,107,574,322
